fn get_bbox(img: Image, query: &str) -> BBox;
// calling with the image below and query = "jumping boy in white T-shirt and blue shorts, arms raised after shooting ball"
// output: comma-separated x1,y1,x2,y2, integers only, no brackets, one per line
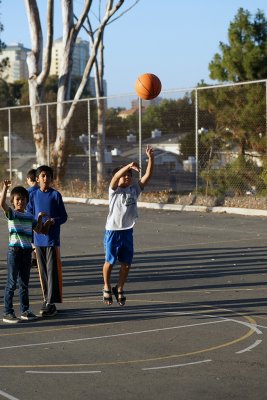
103,146,154,306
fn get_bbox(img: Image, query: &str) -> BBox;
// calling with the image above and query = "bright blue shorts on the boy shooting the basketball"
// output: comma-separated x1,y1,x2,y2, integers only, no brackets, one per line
104,228,134,265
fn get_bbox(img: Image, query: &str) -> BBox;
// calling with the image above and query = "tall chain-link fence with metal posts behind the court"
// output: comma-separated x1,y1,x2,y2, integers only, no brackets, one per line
0,80,267,205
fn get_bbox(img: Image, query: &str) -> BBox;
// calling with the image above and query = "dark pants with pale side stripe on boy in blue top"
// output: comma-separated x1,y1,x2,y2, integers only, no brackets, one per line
35,246,62,304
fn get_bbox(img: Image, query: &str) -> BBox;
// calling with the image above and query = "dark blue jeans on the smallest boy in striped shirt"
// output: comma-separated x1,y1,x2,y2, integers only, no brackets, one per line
4,247,32,314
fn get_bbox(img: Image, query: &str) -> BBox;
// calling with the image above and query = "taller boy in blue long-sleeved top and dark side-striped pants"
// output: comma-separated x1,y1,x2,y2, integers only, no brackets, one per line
27,165,68,317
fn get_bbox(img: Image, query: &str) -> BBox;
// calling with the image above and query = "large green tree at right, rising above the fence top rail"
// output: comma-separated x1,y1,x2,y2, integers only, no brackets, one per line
199,8,267,155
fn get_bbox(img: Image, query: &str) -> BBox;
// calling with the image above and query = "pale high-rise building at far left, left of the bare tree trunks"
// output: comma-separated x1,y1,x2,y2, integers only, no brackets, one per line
0,43,30,83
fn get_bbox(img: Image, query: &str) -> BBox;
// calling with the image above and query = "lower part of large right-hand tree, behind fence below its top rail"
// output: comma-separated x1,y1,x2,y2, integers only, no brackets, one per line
199,83,266,154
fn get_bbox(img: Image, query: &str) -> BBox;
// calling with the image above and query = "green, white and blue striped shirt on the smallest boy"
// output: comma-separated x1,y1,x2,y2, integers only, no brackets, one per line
6,207,37,249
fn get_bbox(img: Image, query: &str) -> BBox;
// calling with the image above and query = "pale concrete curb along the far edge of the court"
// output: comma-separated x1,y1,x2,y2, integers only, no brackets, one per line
63,197,267,217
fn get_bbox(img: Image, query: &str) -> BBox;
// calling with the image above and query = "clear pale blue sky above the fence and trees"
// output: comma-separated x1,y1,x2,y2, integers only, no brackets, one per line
0,0,267,96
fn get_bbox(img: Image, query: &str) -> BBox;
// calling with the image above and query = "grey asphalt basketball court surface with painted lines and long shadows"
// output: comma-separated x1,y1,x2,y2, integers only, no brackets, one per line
0,204,267,400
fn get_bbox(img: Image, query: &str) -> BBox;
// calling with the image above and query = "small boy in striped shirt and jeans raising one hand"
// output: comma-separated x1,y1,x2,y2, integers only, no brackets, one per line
0,180,51,324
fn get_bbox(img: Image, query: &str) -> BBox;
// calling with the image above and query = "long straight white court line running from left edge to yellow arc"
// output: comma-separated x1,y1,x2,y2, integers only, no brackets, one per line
0,318,227,350
